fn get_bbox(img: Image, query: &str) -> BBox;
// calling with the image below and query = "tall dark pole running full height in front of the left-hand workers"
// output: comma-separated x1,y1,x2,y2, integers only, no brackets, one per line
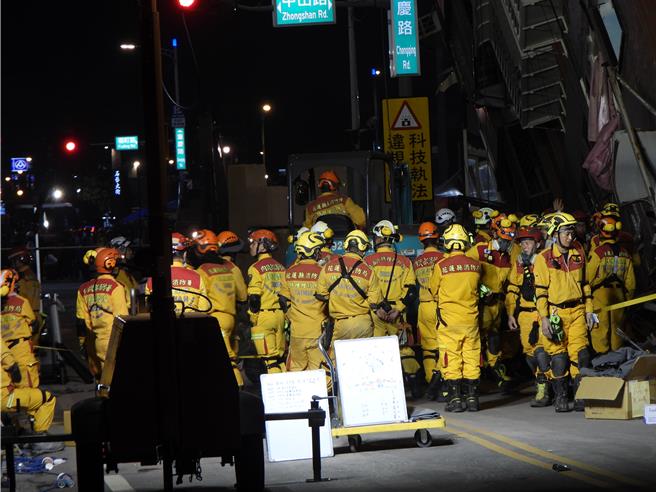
141,0,179,490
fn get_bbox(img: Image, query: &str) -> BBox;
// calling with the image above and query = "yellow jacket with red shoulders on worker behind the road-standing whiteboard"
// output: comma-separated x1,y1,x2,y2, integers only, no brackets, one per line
280,259,327,338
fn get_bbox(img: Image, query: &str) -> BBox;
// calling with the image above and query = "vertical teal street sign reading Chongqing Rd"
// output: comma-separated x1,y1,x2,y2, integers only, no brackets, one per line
389,0,421,77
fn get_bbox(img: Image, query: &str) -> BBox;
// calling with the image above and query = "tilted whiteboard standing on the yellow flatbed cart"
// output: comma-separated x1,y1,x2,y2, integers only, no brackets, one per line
335,336,408,427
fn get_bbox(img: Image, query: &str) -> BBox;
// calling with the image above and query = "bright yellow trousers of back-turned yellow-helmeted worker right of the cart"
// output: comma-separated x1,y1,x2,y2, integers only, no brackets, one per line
437,325,481,380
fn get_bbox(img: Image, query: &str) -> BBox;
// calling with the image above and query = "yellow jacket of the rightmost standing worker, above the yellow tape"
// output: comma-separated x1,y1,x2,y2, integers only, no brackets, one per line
586,239,636,299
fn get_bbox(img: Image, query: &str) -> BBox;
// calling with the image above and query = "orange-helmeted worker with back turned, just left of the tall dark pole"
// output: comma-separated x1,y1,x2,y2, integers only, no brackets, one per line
76,248,129,378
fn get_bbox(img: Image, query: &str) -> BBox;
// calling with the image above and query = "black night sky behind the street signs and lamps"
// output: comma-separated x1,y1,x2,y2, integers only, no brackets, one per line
2,0,394,177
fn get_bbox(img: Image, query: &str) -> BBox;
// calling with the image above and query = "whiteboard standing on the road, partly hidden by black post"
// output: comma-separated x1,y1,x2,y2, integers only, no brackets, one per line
260,369,334,462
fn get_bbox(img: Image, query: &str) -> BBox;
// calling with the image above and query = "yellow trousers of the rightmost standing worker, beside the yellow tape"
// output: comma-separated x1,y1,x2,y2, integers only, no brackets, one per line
590,287,626,354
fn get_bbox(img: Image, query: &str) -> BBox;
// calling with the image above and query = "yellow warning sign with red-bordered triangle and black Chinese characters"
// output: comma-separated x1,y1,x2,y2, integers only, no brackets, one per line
383,97,433,201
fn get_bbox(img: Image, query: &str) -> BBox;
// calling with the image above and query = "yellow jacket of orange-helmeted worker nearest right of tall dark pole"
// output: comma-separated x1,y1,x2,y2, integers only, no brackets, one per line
196,261,246,316
